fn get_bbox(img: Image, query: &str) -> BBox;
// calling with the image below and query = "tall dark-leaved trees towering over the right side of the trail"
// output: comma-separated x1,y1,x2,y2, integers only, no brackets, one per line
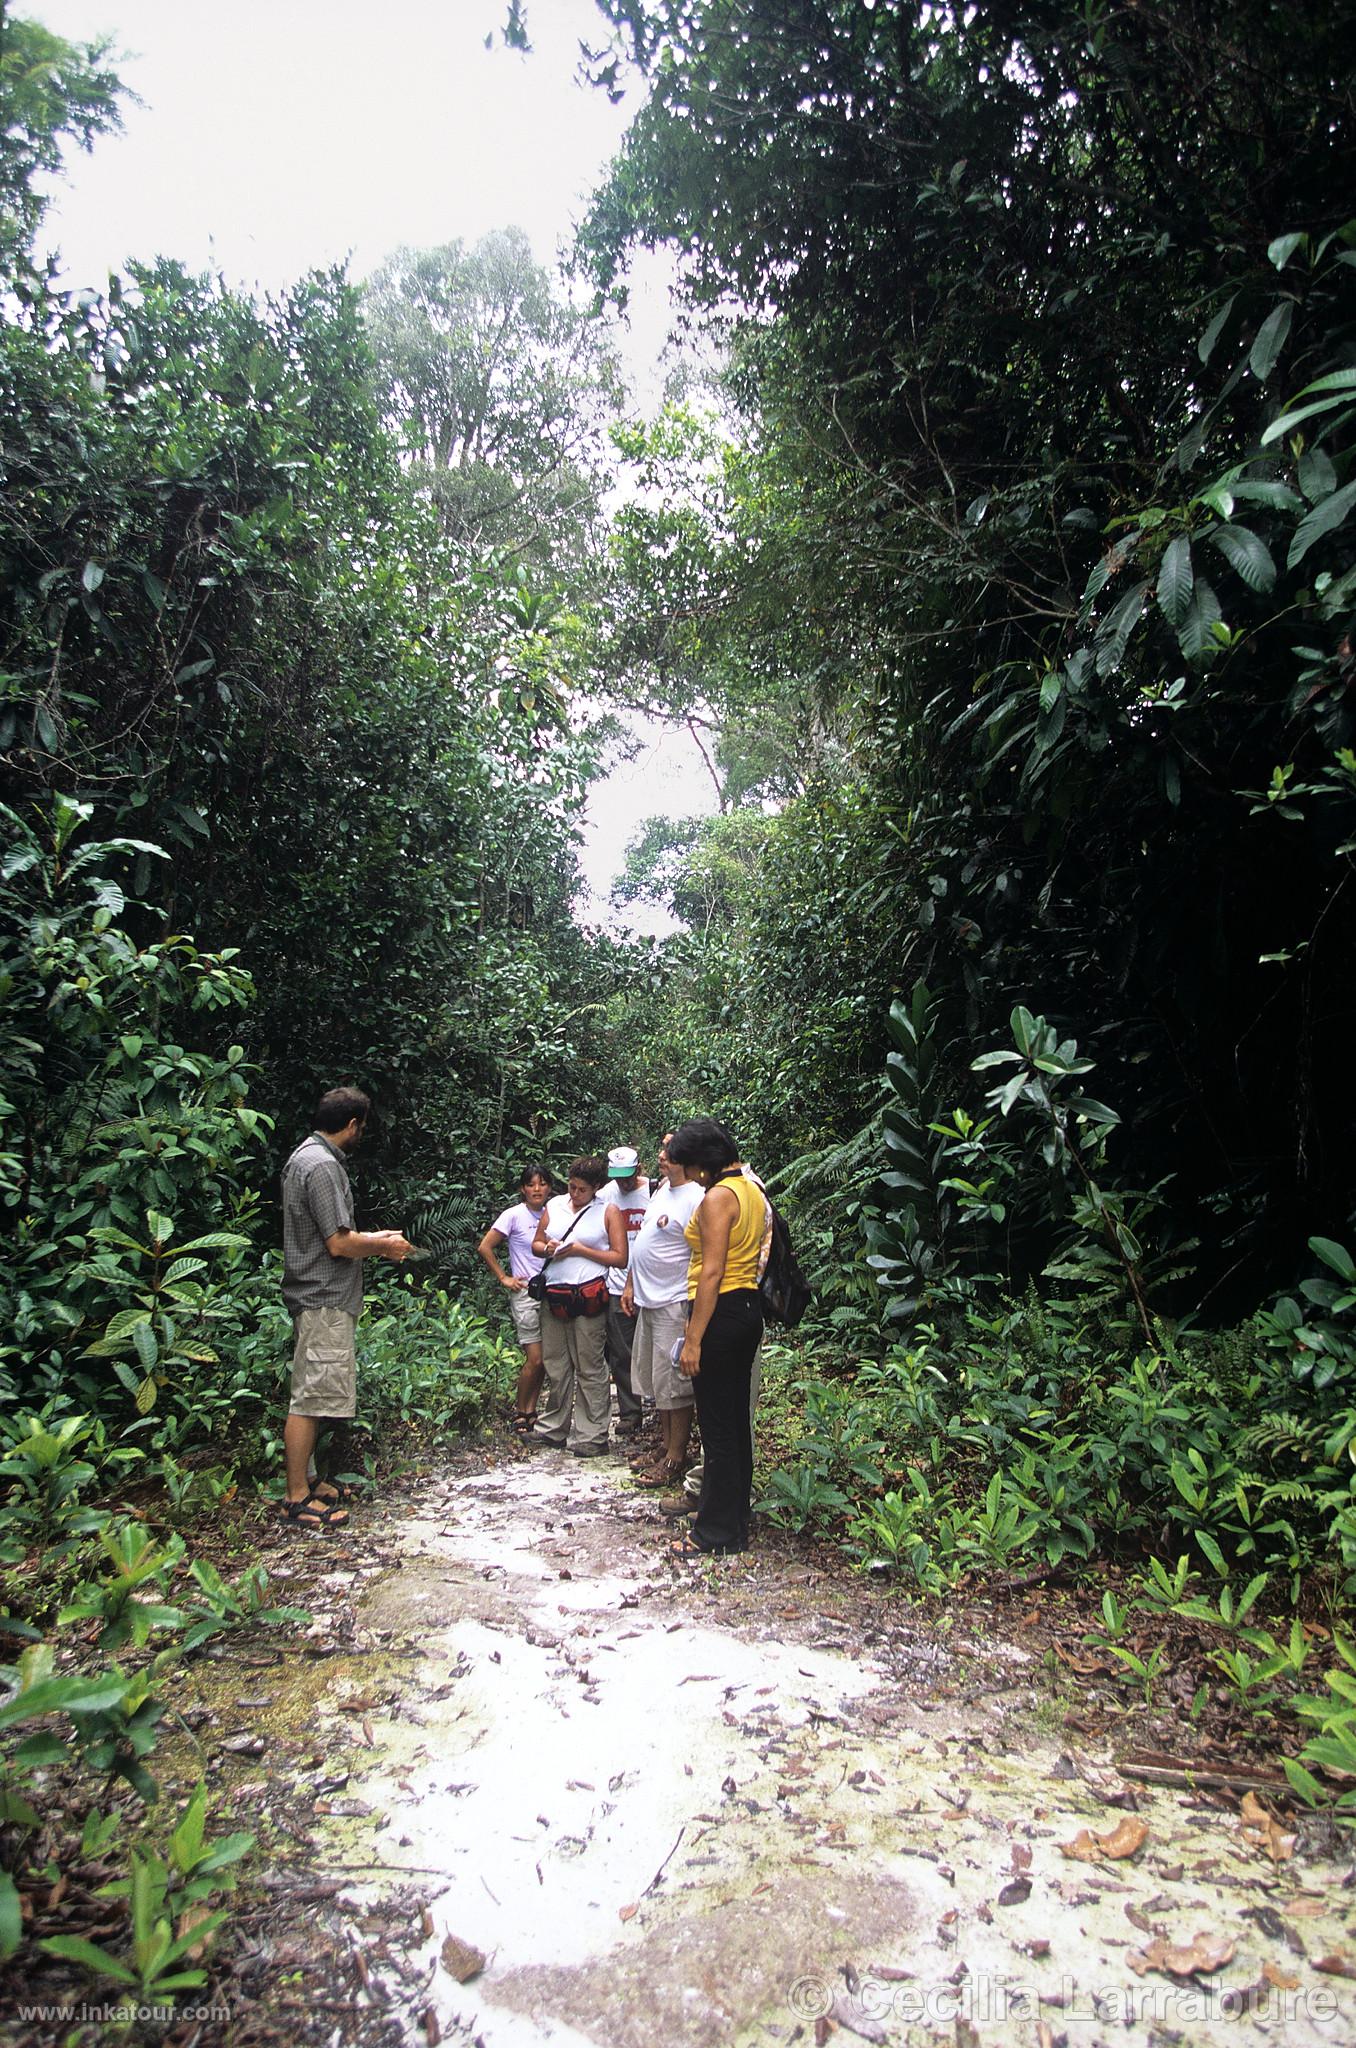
586,0,1356,1286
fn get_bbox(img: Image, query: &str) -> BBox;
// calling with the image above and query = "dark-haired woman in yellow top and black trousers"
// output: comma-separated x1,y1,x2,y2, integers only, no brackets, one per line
668,1116,768,1556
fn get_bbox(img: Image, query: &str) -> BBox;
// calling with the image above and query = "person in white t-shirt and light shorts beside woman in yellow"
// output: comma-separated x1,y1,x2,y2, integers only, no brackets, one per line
621,1137,707,1487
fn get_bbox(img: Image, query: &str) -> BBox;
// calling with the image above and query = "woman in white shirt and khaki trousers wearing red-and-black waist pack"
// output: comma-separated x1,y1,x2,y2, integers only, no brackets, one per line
526,1159,627,1458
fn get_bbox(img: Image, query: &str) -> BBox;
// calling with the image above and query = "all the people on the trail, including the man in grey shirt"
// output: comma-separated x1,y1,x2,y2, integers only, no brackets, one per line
281,1087,770,1556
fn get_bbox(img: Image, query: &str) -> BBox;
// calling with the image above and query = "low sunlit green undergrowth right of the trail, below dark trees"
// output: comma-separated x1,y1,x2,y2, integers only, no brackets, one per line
762,1239,1356,1606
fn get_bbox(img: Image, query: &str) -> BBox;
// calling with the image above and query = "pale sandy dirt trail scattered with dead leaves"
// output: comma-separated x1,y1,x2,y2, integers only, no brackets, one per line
301,1456,1356,2048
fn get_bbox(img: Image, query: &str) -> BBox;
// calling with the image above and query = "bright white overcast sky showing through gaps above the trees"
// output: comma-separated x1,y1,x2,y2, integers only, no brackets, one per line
26,0,713,928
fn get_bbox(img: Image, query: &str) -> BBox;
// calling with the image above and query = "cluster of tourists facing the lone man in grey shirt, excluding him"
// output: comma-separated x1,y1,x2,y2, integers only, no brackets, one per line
479,1118,770,1556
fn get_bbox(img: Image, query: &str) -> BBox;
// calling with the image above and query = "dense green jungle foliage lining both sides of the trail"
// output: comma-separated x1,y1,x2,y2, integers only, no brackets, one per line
0,0,1356,1982
